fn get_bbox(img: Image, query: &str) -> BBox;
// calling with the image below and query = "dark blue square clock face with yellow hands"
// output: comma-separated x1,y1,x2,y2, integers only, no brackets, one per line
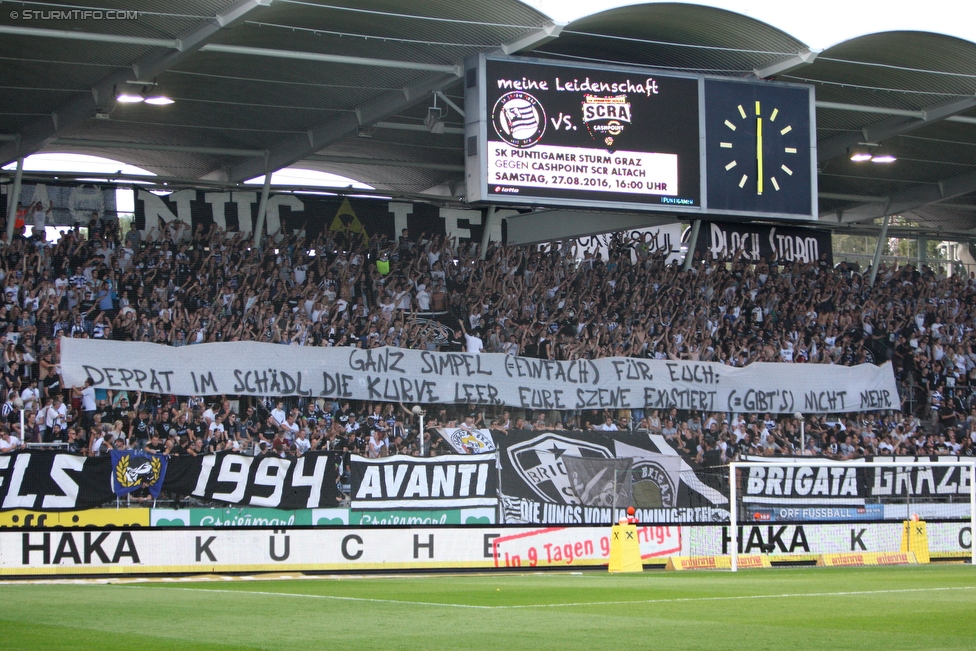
705,79,813,216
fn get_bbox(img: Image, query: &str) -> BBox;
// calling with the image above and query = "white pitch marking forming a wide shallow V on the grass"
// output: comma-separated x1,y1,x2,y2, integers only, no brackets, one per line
108,584,976,610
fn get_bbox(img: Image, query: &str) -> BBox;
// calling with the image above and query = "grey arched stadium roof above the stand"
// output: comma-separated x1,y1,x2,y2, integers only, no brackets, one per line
0,0,976,239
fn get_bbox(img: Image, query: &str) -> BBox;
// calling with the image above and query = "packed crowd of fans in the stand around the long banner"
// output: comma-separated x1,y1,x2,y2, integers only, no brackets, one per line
0,211,976,465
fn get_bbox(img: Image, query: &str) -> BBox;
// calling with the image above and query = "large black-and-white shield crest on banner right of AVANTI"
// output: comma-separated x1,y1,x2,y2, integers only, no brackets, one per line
508,432,613,504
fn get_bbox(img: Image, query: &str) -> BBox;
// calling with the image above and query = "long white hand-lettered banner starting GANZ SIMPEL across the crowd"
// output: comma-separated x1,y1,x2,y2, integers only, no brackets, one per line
61,339,898,414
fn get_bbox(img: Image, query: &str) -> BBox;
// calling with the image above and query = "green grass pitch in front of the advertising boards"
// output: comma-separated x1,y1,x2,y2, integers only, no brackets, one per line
0,565,976,651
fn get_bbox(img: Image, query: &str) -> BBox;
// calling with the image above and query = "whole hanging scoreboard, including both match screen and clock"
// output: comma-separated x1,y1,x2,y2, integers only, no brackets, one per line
465,55,816,219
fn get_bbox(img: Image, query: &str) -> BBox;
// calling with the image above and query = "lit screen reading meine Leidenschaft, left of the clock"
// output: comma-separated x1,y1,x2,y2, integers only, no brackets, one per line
474,59,701,206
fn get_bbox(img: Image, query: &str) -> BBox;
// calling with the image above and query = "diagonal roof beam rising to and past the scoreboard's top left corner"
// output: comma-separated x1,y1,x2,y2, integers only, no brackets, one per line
227,24,562,182
